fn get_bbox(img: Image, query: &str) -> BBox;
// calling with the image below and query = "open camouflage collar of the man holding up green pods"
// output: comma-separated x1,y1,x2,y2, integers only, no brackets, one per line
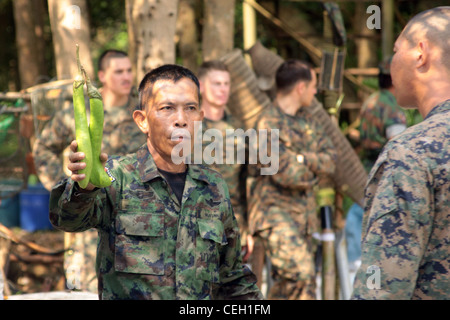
136,143,210,184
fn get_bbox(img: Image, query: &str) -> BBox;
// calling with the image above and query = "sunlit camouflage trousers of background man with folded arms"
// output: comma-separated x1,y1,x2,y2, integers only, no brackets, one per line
258,221,316,300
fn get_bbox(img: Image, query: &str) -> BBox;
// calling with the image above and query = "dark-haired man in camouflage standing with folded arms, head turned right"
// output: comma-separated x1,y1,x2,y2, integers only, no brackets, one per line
249,60,336,300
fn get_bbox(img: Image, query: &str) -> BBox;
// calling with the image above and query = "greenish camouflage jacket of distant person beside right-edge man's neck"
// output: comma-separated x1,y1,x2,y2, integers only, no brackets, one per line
359,90,406,169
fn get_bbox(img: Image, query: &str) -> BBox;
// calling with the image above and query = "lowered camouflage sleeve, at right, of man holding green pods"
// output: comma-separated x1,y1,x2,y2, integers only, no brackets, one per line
215,179,263,300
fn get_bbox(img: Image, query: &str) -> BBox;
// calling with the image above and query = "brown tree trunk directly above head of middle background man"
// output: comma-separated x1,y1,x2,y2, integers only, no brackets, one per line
202,0,235,60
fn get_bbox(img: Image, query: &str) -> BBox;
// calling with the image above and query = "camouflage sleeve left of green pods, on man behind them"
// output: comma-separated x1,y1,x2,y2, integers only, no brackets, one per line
32,102,75,191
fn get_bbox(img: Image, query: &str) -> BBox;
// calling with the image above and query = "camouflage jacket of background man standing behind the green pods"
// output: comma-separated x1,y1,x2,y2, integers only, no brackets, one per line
33,98,147,190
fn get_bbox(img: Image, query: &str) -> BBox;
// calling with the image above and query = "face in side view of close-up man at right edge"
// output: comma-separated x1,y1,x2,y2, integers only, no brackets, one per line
391,35,415,108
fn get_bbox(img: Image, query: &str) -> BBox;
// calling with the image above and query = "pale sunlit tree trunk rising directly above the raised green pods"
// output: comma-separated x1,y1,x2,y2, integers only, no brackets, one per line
48,0,95,80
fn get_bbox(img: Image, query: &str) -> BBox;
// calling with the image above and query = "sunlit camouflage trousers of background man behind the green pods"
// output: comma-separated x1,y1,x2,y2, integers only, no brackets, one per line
64,229,98,293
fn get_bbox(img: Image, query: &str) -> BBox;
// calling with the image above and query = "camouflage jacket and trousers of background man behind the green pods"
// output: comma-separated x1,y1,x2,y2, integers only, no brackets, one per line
33,94,146,292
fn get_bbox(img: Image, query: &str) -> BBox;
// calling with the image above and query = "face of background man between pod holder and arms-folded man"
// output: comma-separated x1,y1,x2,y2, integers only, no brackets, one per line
200,70,231,107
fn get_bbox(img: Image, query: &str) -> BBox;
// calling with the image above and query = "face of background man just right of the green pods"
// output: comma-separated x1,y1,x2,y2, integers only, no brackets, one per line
98,57,133,96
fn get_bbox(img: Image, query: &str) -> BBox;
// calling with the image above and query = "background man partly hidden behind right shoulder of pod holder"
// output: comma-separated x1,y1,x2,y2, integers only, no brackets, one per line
198,60,248,258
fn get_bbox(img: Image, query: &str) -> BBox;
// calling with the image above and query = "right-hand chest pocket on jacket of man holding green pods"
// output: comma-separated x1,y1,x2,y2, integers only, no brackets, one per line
195,219,227,283
